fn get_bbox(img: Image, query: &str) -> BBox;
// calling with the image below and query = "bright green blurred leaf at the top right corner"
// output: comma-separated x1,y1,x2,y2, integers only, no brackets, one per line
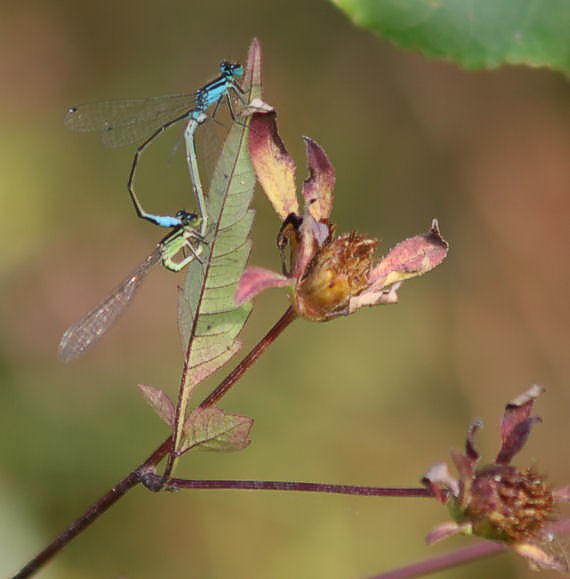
332,0,570,74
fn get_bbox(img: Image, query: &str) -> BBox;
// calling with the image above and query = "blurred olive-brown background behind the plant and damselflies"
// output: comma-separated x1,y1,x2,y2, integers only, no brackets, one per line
0,0,570,579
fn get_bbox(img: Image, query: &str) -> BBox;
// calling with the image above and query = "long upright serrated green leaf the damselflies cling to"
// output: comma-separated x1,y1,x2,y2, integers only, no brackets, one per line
175,40,261,452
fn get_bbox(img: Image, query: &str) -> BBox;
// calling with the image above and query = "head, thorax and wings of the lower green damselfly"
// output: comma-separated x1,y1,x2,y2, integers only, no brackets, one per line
58,211,205,362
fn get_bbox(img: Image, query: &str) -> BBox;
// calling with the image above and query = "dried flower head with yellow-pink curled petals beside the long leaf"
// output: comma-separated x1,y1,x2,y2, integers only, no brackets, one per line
236,112,448,321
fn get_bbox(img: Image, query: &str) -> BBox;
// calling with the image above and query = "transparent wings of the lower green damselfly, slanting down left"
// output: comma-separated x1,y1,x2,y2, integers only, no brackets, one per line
58,246,162,362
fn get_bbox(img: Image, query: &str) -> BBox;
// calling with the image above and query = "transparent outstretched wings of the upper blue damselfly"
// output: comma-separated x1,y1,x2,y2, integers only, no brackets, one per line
63,94,195,148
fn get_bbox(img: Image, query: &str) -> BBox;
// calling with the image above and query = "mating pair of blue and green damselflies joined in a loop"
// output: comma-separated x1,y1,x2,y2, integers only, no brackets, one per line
58,62,245,362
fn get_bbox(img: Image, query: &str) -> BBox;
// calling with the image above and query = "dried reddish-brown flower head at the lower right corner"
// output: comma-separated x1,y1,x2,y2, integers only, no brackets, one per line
423,386,568,572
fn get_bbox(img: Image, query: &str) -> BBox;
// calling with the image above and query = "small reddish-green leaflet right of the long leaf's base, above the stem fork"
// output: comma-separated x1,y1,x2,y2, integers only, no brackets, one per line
180,407,253,453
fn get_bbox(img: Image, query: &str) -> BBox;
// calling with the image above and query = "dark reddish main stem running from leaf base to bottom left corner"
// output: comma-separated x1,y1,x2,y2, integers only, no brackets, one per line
14,437,172,579
